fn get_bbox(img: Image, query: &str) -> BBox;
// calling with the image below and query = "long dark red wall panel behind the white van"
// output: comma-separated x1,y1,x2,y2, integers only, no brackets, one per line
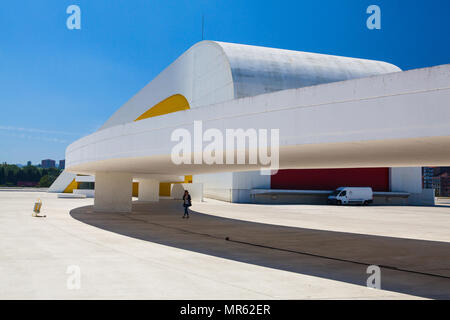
270,168,389,191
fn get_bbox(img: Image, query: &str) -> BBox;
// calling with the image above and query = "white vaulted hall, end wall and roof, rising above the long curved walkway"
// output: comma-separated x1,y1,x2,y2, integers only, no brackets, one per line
100,41,401,130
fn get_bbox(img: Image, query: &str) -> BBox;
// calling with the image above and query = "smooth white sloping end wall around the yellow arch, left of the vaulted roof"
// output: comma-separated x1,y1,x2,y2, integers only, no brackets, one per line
100,41,234,130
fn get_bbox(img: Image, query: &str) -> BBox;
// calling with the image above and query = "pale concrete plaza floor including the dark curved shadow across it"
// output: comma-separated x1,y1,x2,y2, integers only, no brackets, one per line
0,191,450,299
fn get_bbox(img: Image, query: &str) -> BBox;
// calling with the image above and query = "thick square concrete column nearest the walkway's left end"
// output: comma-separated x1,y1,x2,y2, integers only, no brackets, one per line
94,172,133,212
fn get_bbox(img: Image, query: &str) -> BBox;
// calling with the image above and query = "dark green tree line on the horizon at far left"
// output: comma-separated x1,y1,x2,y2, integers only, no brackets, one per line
0,163,62,187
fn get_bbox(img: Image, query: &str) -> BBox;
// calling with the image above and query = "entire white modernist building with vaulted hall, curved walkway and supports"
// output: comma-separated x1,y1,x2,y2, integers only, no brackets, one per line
58,41,450,211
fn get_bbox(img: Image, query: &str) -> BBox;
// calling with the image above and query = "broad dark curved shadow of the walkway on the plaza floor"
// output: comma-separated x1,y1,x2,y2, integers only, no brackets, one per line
70,200,450,299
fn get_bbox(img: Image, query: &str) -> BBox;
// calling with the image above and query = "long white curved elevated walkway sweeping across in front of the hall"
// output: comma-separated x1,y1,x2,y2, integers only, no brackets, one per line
66,65,450,176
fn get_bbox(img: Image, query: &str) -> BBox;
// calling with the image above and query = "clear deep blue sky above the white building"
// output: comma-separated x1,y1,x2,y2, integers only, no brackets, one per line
0,0,450,163
